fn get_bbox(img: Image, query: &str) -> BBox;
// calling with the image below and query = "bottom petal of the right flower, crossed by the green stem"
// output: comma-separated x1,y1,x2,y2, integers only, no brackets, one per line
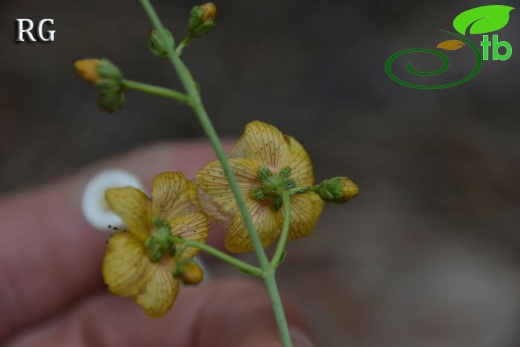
225,198,282,253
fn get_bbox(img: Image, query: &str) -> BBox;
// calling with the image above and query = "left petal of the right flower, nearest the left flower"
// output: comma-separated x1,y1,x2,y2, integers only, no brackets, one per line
195,158,261,226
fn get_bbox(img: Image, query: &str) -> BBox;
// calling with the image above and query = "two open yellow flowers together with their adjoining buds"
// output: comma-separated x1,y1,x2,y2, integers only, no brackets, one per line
103,121,359,317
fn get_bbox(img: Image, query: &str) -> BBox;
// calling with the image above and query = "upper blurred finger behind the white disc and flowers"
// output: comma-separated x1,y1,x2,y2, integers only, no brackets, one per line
0,141,230,342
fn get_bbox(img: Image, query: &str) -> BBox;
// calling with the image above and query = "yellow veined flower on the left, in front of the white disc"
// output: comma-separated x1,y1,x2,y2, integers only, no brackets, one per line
103,172,209,317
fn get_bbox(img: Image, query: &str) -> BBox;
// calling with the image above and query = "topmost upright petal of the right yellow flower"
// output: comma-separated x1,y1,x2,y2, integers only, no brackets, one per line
229,121,289,174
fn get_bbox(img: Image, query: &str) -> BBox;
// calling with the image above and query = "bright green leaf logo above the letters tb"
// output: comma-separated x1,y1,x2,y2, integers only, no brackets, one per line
453,5,514,35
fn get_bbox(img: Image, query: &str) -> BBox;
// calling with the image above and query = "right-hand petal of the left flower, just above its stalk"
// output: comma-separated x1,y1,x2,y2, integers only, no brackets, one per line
169,213,209,258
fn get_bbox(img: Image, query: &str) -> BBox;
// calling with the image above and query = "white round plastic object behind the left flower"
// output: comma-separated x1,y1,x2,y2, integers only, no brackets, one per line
81,169,144,233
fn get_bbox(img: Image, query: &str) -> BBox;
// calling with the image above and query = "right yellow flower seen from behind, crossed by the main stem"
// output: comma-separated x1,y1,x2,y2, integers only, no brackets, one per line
195,121,324,253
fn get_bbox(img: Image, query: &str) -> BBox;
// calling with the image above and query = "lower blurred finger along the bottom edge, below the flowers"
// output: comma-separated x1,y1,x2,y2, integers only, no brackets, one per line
6,279,314,347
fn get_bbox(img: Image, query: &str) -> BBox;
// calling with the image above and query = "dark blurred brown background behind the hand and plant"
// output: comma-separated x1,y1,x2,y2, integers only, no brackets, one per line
0,0,520,347
